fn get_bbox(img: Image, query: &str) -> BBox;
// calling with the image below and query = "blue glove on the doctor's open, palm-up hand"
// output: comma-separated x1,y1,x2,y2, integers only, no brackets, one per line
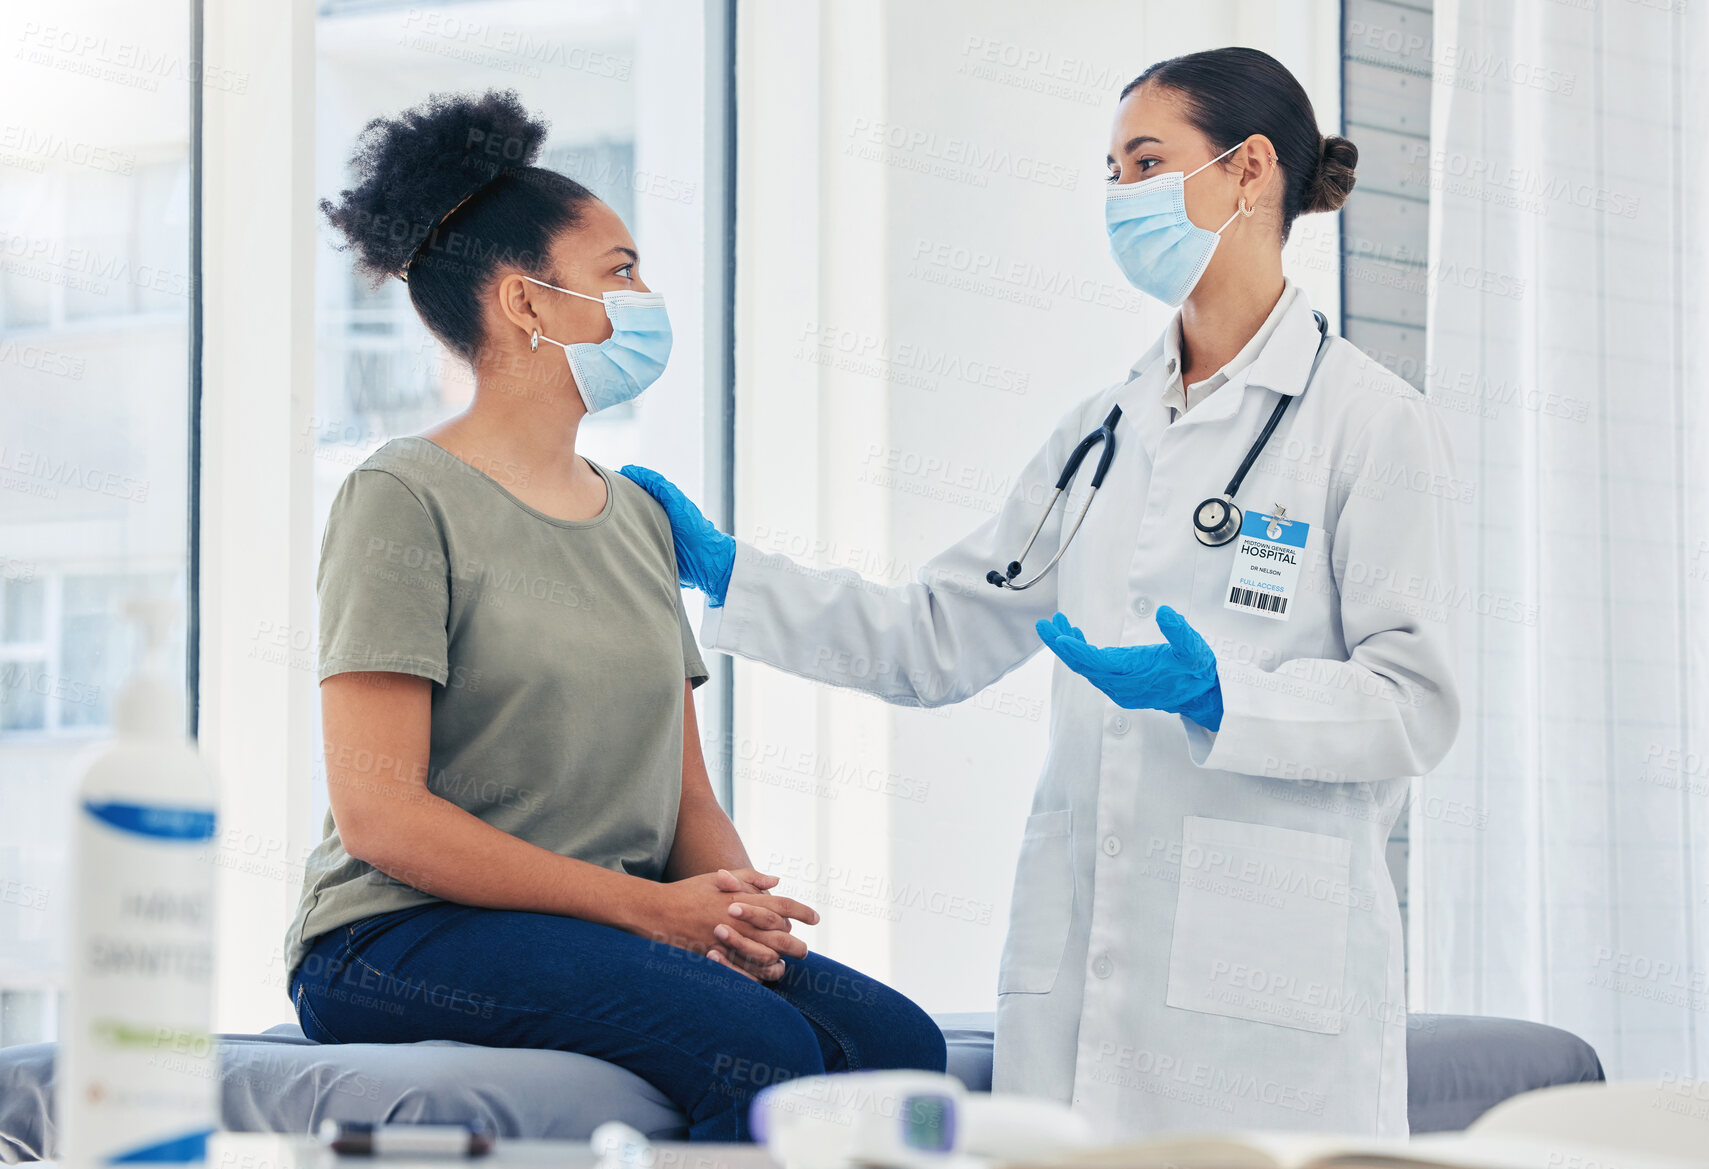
1037,605,1222,730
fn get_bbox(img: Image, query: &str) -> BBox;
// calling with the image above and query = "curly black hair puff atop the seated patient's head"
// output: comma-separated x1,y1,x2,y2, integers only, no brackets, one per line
320,89,550,280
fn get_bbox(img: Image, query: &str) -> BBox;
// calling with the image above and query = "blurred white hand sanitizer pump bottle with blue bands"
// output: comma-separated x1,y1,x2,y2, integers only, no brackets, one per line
55,598,219,1166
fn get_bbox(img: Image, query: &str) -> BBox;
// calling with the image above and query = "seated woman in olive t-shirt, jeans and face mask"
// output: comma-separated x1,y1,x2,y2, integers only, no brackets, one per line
285,92,945,1140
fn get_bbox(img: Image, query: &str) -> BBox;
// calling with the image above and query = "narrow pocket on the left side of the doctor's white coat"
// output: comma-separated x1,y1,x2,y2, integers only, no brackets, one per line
996,808,1073,995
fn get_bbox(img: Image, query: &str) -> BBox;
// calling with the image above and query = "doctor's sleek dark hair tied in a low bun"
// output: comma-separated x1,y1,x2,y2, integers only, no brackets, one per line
1121,48,1359,243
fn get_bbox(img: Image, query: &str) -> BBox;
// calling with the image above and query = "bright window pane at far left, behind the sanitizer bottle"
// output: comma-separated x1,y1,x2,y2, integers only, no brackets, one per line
0,0,193,1044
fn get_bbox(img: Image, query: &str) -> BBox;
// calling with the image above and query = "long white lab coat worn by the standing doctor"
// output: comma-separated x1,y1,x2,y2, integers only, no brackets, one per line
701,292,1466,1137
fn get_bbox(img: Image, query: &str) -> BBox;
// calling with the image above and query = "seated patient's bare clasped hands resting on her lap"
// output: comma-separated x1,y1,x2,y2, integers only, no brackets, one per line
649,868,819,983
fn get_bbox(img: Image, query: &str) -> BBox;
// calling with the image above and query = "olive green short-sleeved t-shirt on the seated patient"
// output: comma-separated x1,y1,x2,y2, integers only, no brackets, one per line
284,436,706,981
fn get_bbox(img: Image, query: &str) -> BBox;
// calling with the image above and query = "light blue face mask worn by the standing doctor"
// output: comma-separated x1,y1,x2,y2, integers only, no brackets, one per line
1104,142,1256,306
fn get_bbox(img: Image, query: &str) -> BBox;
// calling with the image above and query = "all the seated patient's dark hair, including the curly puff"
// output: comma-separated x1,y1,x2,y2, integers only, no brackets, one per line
320,89,595,359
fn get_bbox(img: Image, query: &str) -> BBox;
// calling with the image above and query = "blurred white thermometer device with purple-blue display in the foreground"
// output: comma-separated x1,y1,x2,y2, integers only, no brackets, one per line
752,1072,1094,1169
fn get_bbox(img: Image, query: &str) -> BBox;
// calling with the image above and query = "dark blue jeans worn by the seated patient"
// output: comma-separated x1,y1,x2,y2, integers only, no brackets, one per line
291,901,947,1140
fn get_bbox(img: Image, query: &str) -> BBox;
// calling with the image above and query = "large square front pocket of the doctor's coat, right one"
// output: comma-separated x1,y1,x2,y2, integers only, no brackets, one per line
1164,815,1352,1036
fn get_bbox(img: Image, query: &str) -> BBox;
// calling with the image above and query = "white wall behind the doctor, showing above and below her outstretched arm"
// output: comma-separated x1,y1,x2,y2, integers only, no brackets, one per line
735,0,1340,1010
